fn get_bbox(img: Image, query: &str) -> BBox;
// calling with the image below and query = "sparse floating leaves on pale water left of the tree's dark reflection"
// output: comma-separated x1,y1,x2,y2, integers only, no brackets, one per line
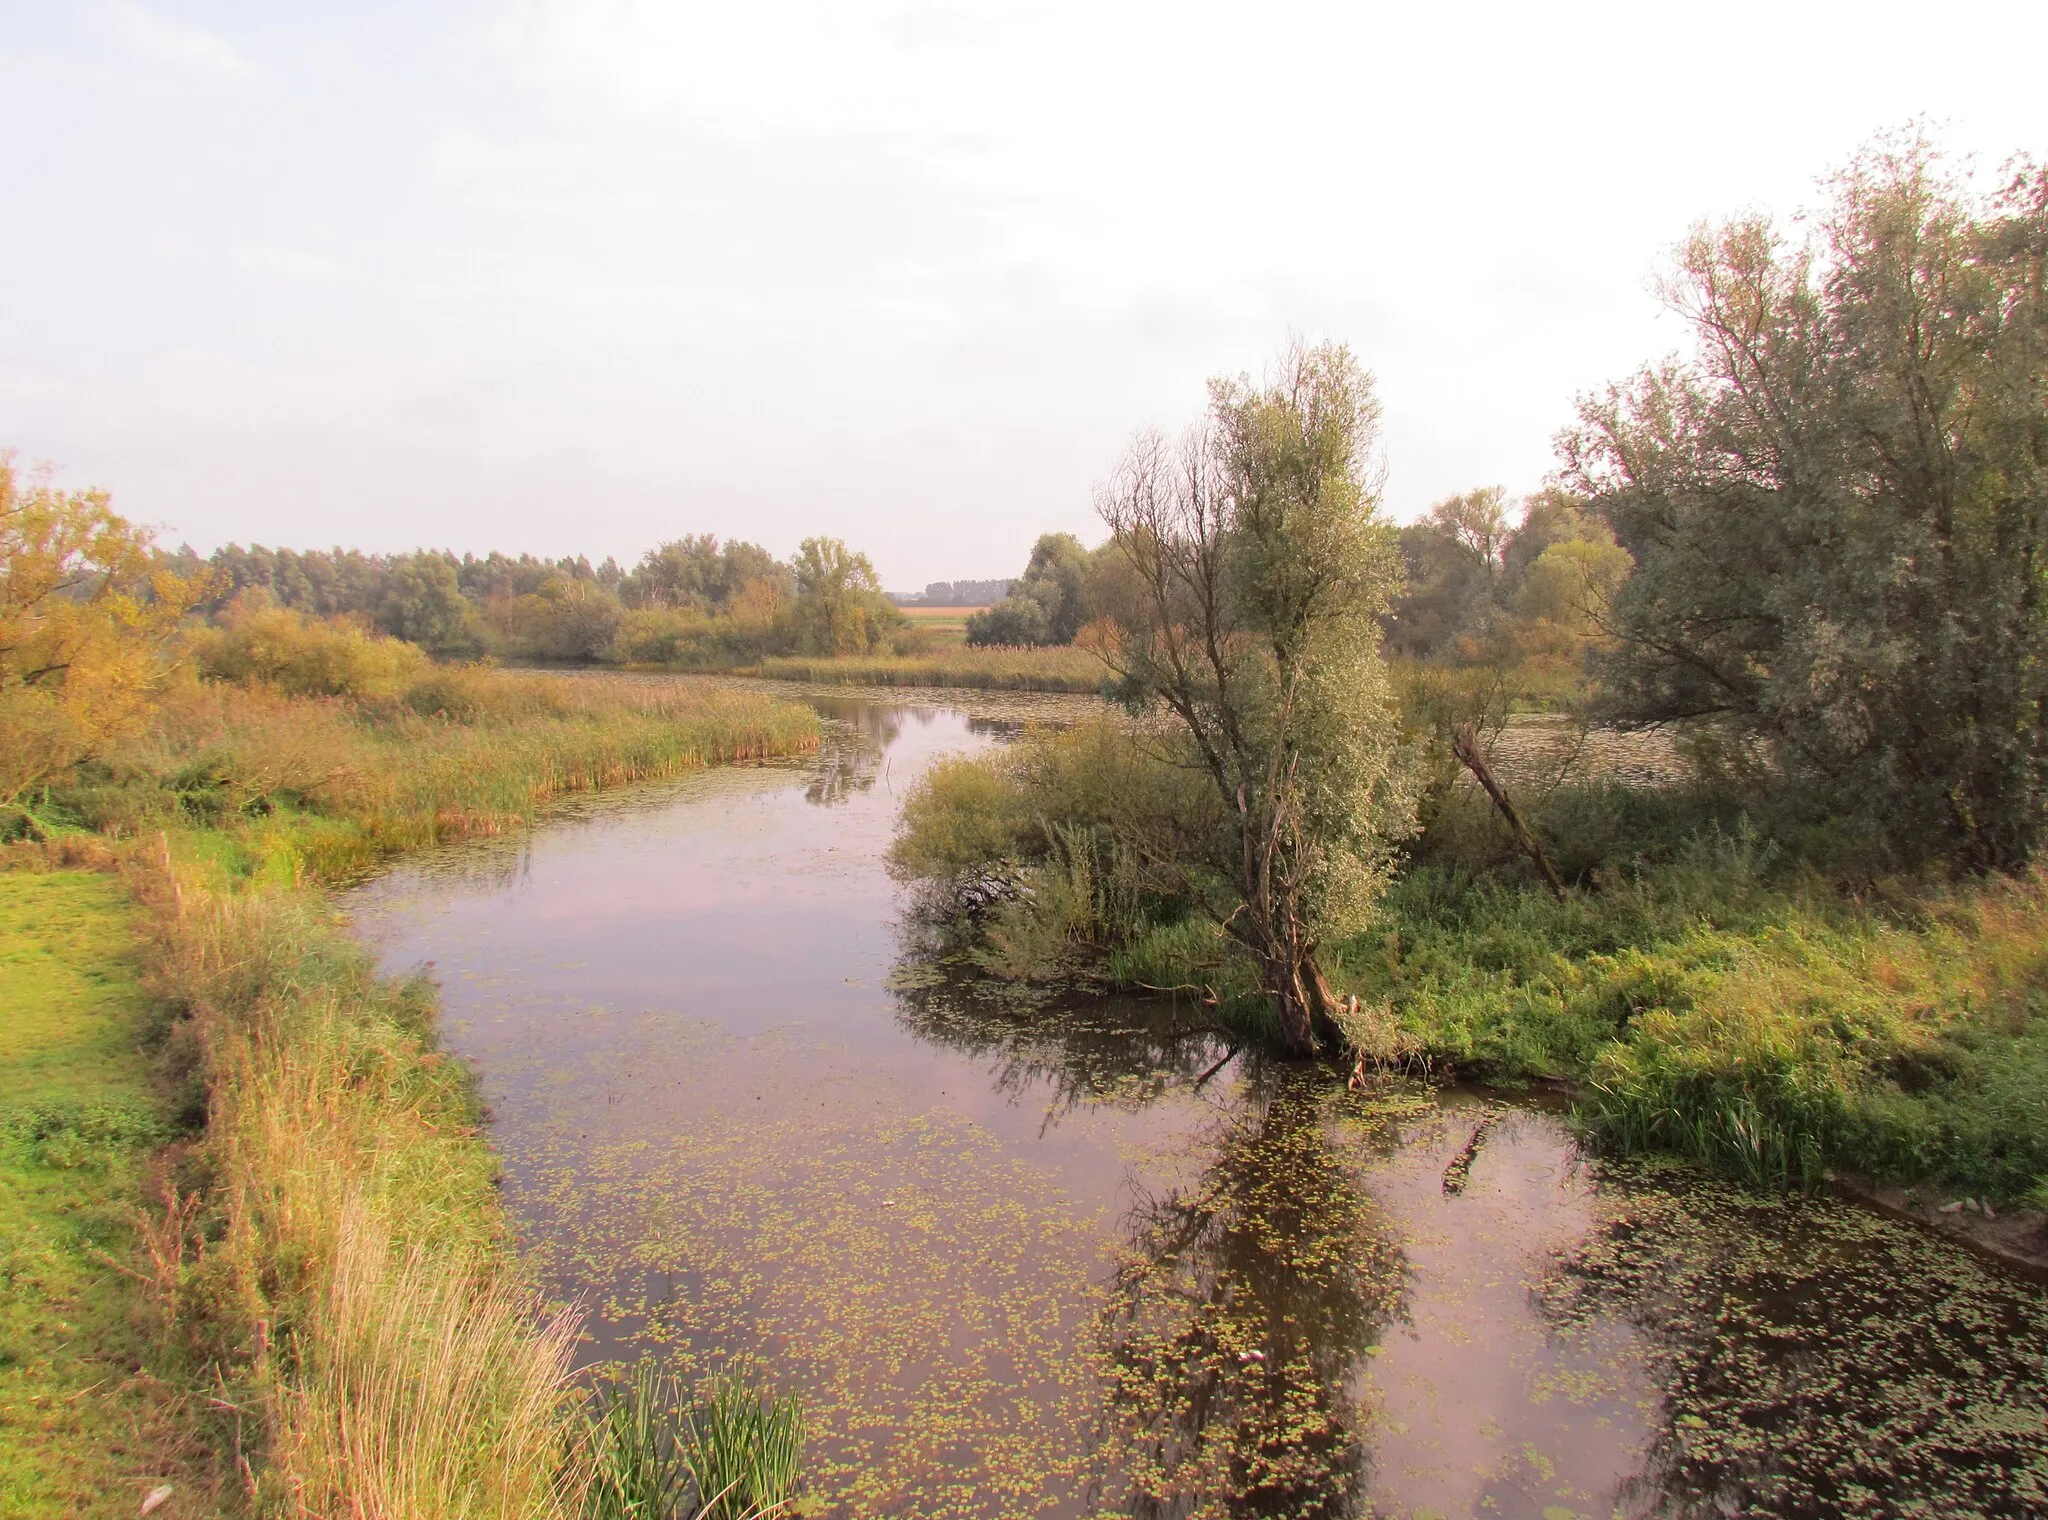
507,1028,1102,1514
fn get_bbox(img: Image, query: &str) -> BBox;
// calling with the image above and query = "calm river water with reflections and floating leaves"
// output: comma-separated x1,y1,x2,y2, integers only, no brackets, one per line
346,694,2048,1520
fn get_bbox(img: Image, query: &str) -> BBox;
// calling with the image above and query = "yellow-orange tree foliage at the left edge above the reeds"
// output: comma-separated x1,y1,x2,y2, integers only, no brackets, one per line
0,453,205,807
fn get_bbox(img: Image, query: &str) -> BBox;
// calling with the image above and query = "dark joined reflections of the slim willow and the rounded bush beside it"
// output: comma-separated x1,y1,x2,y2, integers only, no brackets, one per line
897,961,1405,1520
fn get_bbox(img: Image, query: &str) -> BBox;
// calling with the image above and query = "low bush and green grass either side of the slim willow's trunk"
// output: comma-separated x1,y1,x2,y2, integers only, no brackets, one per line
893,725,2048,1207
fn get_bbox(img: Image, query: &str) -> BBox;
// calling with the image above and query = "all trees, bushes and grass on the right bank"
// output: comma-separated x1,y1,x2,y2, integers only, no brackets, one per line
893,137,2048,1207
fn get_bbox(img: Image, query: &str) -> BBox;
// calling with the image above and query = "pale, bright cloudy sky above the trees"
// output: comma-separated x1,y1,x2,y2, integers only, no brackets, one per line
0,0,2048,590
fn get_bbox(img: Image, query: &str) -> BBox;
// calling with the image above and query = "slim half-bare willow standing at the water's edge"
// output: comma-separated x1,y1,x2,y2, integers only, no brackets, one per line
1098,344,1413,1053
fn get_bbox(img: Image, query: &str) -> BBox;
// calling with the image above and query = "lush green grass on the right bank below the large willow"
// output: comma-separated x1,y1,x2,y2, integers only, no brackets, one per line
1339,838,2048,1207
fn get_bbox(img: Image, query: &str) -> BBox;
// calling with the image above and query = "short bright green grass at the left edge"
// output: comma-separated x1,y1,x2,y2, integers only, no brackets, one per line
0,871,197,1516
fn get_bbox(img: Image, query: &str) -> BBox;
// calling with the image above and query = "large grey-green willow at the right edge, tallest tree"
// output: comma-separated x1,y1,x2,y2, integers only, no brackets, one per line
1565,141,2048,869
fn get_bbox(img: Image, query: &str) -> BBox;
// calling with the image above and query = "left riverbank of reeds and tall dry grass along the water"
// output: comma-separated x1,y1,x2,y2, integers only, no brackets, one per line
0,672,817,1516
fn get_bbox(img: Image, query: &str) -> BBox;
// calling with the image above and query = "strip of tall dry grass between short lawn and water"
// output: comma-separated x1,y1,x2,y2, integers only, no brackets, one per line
145,852,582,1520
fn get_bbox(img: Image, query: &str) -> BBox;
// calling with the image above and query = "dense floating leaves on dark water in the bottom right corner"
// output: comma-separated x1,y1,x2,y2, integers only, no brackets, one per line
1542,1168,2048,1518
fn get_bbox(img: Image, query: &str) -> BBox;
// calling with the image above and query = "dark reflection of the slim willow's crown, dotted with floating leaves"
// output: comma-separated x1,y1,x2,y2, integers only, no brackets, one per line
1100,1069,1403,1520
